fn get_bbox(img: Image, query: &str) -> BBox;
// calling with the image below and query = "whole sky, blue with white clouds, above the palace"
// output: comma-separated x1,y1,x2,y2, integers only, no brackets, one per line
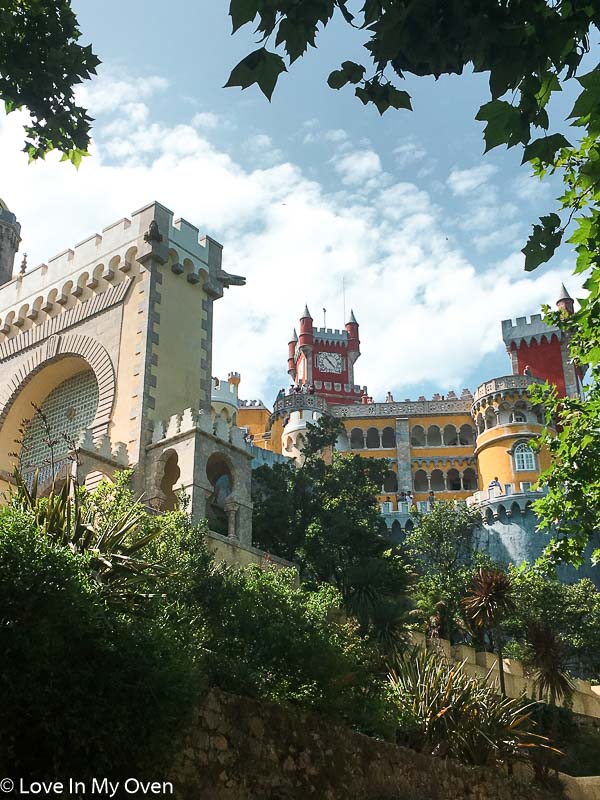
0,0,577,402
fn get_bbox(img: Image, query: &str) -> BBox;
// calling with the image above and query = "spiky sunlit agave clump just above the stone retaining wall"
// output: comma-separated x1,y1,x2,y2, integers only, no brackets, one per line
390,649,550,766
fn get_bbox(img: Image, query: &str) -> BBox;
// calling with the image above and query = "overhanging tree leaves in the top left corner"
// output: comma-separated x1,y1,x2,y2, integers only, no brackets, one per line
0,0,100,166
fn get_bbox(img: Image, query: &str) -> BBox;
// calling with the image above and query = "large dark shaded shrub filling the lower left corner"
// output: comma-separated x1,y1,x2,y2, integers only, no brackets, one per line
0,508,203,778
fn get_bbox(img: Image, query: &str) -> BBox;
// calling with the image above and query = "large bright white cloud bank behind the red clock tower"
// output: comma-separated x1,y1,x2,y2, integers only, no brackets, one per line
0,73,568,402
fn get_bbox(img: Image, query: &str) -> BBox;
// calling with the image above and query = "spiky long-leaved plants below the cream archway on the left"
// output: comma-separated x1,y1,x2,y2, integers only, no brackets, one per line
12,469,165,600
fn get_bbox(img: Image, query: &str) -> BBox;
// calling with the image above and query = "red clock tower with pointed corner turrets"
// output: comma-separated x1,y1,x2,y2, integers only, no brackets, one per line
288,307,367,404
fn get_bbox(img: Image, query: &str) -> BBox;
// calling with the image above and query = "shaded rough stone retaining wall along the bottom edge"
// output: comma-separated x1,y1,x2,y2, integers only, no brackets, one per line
167,690,549,800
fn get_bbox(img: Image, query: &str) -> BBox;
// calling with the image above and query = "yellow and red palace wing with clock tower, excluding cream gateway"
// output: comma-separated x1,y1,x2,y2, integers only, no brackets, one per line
237,298,583,575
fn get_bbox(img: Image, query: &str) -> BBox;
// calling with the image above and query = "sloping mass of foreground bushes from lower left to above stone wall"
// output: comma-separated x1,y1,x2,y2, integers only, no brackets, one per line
0,476,556,779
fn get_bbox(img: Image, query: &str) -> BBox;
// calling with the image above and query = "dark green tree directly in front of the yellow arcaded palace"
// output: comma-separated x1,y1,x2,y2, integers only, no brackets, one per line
253,417,407,638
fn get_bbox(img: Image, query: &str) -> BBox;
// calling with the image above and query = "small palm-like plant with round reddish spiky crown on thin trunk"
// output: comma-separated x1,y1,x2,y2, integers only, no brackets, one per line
463,567,514,697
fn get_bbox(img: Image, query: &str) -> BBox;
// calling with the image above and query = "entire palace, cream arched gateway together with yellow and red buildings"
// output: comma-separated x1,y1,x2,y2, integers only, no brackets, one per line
0,201,582,580
